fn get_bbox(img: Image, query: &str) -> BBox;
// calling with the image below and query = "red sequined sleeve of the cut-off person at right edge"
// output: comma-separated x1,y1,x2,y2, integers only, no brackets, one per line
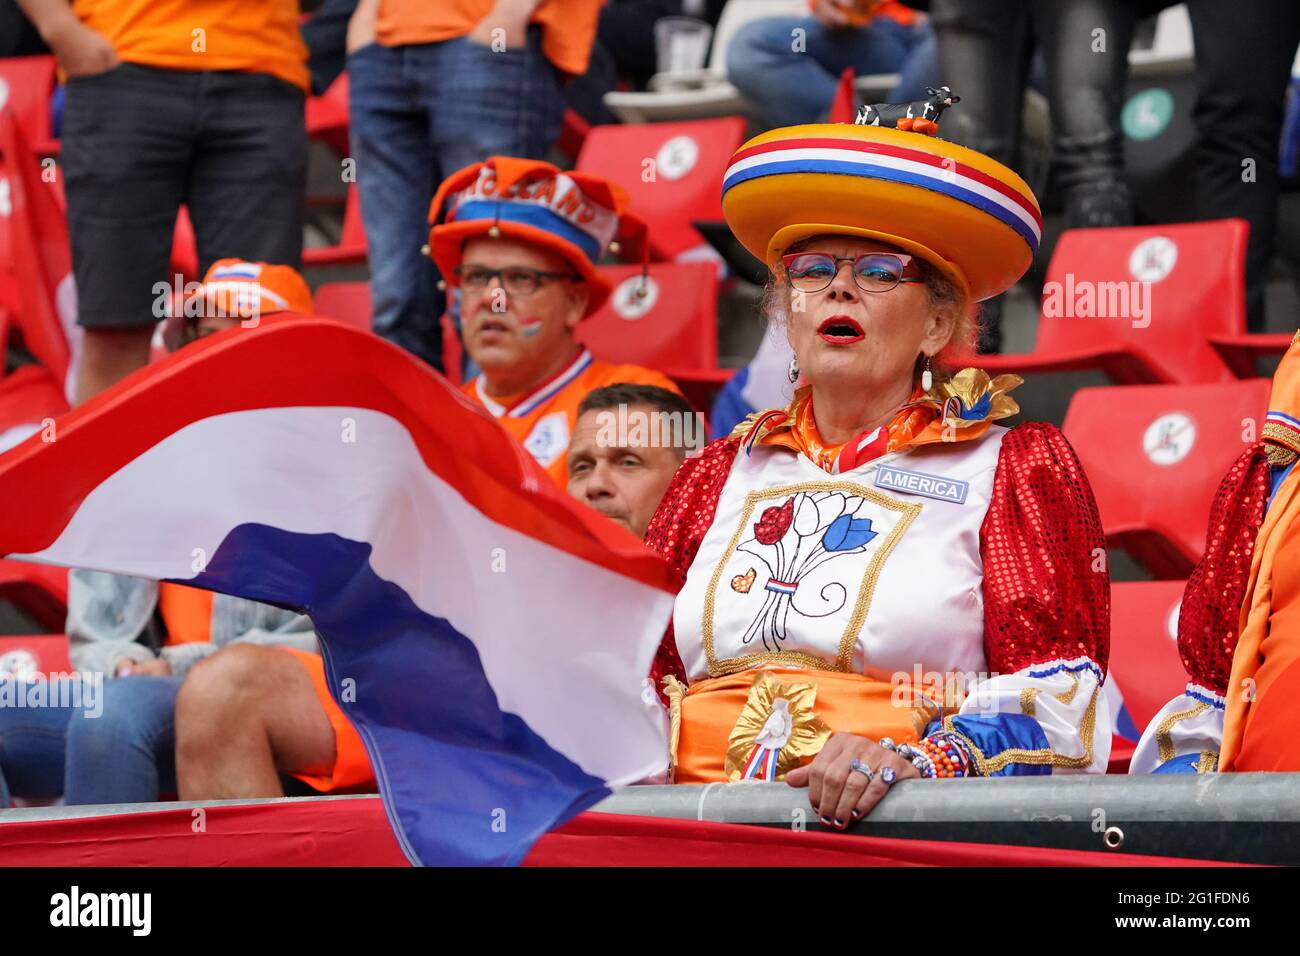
1178,442,1270,696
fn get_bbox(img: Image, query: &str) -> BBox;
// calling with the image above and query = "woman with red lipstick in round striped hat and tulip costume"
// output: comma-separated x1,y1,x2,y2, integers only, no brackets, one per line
646,115,1110,827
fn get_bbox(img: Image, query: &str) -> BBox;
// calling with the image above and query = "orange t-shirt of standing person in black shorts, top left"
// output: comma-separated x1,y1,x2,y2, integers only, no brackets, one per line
73,0,311,92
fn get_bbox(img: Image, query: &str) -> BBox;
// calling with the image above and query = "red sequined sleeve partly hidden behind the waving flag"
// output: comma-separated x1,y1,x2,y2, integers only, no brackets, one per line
646,438,740,696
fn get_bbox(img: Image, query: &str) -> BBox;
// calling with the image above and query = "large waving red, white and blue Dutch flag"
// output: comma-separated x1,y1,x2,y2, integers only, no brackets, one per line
0,319,672,864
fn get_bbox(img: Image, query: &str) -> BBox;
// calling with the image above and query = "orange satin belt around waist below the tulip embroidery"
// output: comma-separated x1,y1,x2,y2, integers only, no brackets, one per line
673,667,924,783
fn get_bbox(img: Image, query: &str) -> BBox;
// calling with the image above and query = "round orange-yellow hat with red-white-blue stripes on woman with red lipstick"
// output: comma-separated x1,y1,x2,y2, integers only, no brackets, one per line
723,124,1043,300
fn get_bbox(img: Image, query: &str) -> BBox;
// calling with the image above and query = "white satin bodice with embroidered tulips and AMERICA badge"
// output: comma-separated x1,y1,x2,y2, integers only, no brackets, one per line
673,425,1006,680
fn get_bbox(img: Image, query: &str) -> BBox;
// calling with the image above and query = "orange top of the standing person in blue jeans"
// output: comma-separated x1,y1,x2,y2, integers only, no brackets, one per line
374,0,605,77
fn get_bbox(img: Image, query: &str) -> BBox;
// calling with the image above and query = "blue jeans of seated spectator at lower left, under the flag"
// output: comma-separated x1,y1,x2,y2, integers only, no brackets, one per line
0,676,181,806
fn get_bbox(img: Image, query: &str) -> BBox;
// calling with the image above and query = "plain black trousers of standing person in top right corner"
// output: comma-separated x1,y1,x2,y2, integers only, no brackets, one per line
1187,0,1300,332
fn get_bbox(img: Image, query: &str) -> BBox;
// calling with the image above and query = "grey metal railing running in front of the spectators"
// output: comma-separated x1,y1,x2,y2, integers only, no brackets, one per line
0,774,1300,865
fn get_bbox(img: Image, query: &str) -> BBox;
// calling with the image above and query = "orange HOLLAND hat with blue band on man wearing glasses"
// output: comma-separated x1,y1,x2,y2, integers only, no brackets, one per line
429,156,631,315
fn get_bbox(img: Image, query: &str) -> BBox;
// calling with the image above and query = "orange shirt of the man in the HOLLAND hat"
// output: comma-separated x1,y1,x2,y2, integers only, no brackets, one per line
460,349,681,489
